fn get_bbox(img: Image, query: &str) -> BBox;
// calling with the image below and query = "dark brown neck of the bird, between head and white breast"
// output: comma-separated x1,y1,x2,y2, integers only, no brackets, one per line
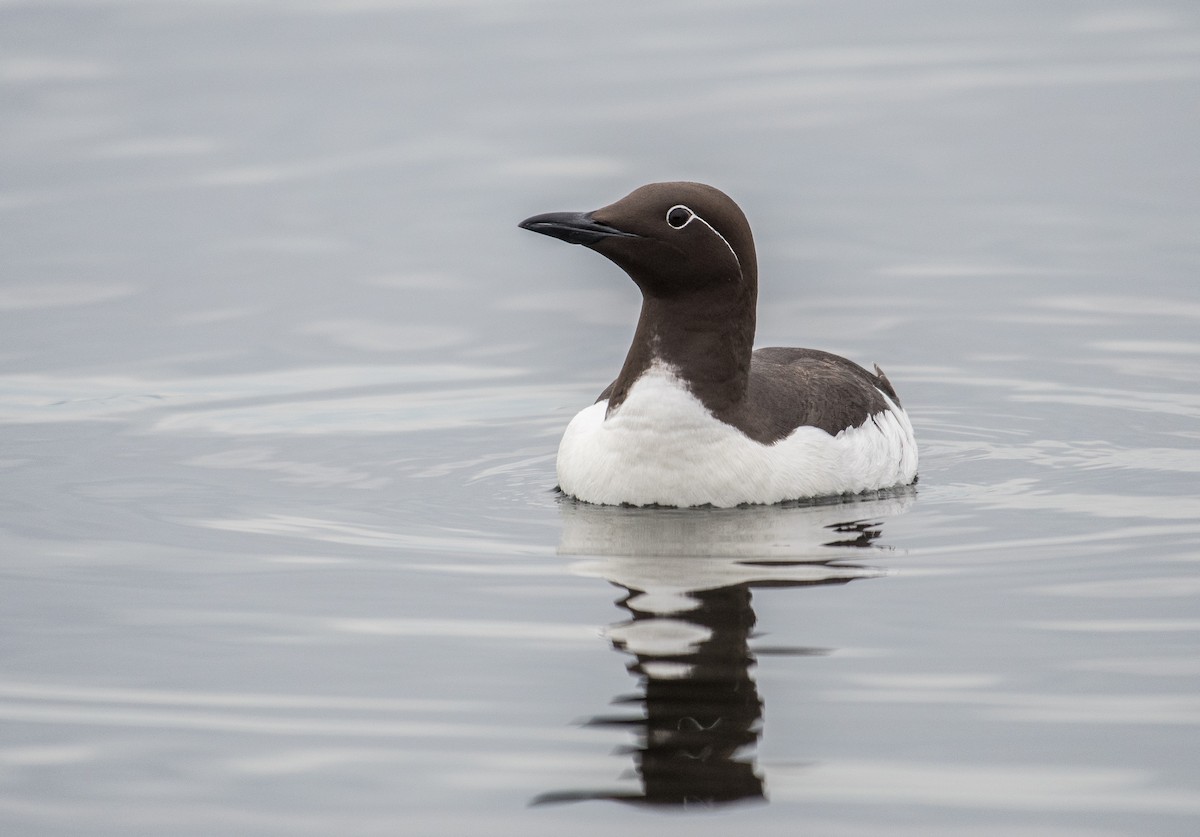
608,288,755,416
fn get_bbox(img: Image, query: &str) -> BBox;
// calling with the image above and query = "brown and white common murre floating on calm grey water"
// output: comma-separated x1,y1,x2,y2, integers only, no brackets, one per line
520,182,917,506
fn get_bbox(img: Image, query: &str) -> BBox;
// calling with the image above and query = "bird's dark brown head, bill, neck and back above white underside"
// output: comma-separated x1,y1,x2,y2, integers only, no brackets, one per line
521,182,900,445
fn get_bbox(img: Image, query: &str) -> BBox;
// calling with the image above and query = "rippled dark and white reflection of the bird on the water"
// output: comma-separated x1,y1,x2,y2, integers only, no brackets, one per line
534,490,912,806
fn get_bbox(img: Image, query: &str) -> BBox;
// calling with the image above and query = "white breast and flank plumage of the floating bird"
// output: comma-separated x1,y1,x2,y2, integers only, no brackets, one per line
558,362,917,506
